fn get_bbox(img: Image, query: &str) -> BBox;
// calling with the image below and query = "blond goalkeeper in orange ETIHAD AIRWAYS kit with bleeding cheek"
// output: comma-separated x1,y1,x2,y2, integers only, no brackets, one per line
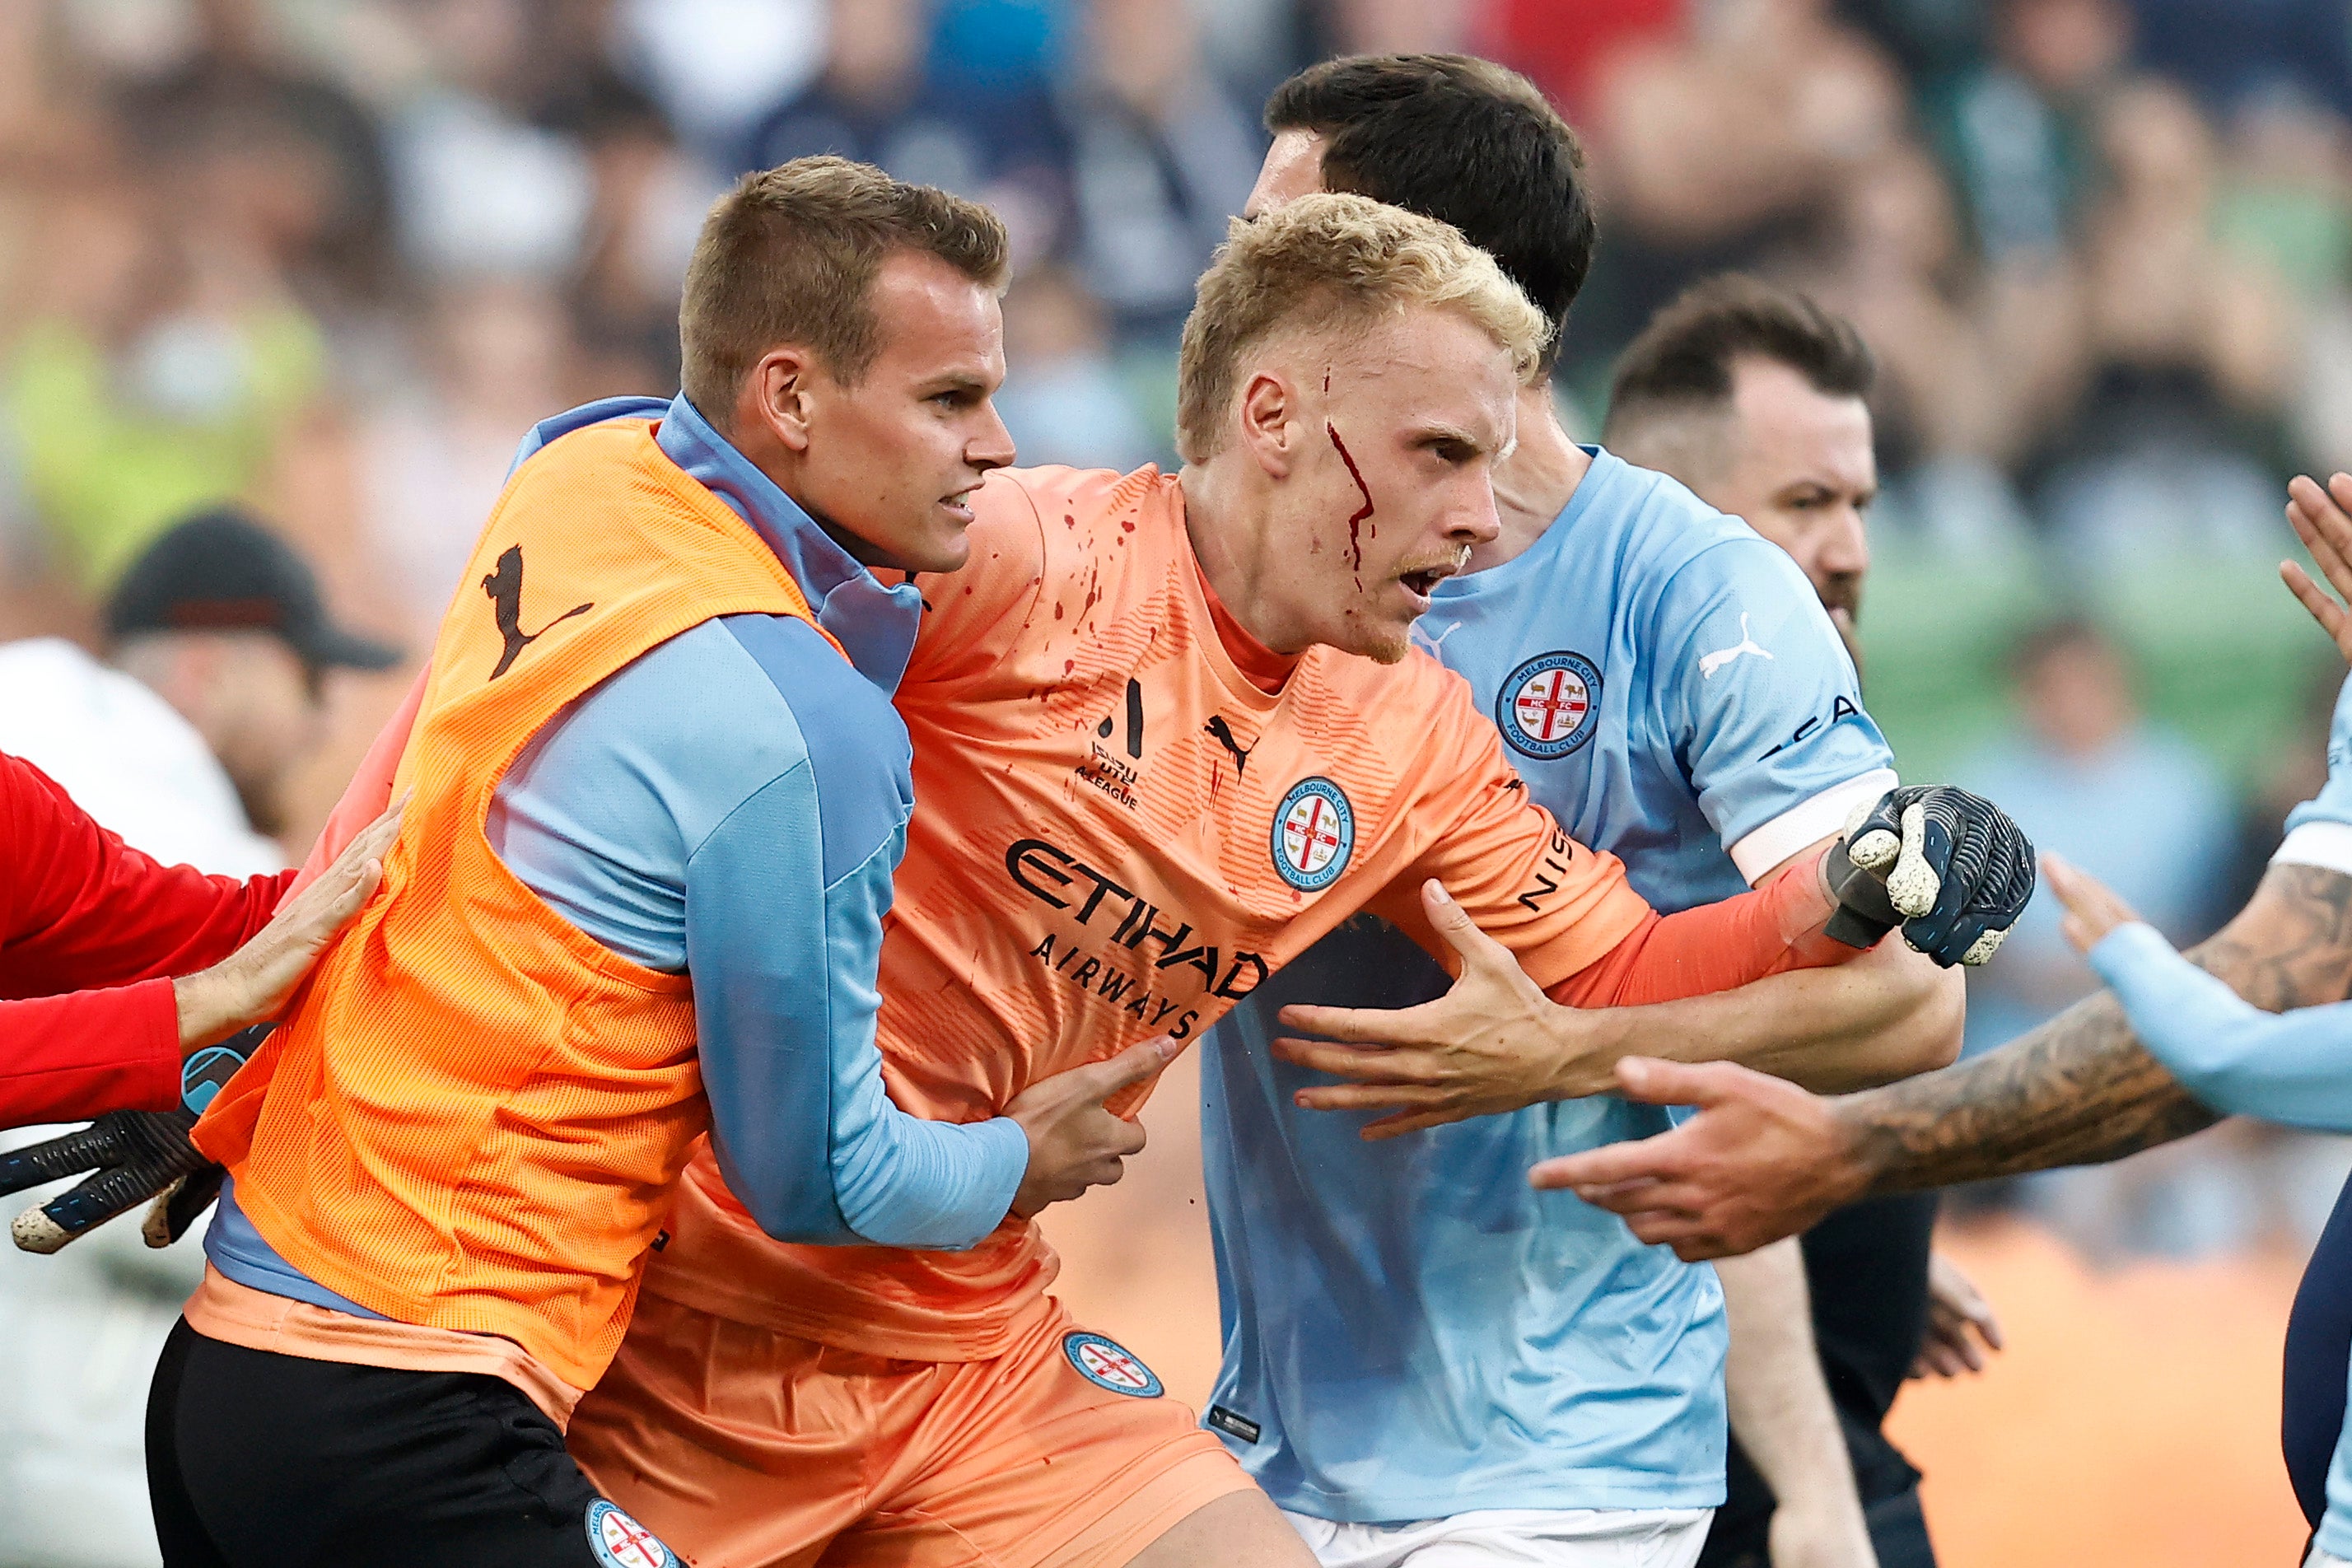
572,195,1938,1568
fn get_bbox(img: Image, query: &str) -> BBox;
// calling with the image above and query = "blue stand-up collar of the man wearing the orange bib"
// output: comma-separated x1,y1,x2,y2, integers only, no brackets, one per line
515,393,922,691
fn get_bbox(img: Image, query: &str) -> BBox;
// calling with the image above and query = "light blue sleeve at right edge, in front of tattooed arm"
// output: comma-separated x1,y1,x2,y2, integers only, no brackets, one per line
2091,922,2352,1133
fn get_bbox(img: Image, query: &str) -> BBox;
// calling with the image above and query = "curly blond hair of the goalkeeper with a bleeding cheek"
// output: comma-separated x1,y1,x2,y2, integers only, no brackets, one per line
1176,193,1550,463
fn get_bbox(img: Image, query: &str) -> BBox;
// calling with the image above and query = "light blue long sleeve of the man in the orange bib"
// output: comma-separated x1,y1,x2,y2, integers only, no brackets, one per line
489,616,1028,1248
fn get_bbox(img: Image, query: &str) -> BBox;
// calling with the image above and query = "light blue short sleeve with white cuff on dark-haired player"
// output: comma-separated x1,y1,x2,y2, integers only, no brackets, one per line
1651,536,1896,881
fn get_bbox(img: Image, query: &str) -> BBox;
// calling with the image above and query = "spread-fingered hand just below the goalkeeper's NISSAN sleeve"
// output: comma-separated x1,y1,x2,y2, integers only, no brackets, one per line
1272,881,1611,1138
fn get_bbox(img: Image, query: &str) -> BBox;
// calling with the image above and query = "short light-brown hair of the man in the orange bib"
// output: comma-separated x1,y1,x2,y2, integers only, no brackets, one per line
678,157,1006,428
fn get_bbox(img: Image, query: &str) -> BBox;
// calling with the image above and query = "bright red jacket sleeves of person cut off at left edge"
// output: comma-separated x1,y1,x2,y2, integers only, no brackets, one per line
0,754,294,1126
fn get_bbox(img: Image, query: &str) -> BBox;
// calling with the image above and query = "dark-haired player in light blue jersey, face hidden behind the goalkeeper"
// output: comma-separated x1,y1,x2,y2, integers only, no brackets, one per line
1202,57,1962,1568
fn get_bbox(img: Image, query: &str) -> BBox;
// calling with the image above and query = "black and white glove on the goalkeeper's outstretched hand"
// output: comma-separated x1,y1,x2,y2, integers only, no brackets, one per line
1825,785,2034,968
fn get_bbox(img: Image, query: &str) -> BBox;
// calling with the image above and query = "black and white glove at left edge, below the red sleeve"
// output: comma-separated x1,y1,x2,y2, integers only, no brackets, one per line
0,1023,261,1253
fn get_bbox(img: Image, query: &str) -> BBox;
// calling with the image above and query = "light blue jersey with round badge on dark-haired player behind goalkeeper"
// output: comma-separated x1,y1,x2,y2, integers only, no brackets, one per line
1202,451,1893,1524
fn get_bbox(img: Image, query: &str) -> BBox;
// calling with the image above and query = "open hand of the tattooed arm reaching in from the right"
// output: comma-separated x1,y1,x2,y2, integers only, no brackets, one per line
1527,1056,1870,1262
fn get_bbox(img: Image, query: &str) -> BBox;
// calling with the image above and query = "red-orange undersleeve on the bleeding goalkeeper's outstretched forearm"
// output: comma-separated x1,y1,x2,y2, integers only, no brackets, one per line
1545,856,1860,1006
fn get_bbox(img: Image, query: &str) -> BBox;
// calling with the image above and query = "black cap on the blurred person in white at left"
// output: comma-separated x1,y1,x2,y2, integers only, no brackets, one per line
106,506,400,670
